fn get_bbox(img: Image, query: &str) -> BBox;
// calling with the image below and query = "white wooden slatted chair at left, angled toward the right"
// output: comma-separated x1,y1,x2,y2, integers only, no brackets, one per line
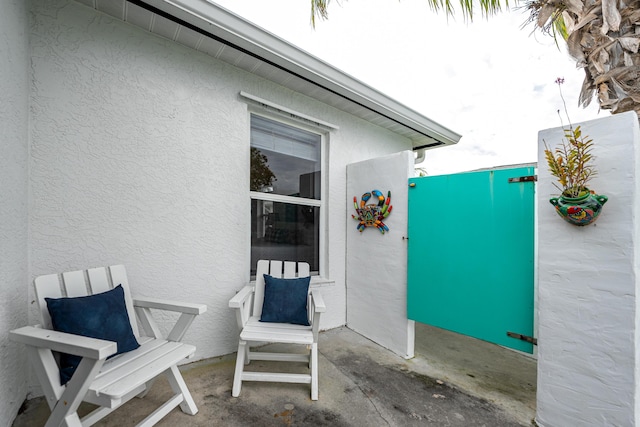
10,265,207,426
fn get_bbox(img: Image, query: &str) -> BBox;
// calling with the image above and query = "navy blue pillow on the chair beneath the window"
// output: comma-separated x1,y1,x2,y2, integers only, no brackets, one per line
260,274,311,326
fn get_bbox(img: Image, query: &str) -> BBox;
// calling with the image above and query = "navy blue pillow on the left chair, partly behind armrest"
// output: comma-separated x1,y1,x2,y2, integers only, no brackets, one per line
45,285,140,385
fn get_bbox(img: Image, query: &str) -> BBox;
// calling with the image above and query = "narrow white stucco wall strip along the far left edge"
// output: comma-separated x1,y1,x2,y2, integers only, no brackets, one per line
0,0,29,426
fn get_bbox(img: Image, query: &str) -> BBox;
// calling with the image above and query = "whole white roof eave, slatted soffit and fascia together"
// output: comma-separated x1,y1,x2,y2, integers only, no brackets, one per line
77,0,460,148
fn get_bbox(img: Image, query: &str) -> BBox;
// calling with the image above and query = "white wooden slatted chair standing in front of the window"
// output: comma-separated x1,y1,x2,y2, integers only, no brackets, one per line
229,260,326,400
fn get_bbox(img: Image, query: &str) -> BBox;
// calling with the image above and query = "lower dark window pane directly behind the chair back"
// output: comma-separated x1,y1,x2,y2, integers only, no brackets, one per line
251,199,320,275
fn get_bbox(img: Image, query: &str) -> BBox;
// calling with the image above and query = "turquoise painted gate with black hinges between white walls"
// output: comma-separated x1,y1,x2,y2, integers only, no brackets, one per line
407,168,535,353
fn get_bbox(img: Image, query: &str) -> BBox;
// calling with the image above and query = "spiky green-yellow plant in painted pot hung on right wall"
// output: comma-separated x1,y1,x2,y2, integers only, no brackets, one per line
544,78,608,225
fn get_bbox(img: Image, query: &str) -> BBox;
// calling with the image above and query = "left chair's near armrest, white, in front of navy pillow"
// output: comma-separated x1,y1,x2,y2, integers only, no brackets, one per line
9,326,118,360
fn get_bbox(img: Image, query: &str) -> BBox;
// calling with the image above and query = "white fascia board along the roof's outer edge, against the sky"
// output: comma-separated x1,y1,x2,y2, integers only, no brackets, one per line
145,0,461,145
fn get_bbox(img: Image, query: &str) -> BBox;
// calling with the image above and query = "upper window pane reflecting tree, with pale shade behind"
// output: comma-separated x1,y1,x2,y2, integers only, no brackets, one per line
250,116,321,200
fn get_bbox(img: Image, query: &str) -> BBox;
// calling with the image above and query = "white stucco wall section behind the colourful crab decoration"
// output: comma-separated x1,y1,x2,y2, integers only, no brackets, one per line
346,151,415,357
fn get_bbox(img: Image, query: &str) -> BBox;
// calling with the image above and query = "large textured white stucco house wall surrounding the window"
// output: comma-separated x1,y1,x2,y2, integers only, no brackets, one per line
22,0,410,398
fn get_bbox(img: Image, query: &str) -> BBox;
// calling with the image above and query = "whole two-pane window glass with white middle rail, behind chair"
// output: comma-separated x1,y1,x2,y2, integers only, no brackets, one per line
250,114,322,275
